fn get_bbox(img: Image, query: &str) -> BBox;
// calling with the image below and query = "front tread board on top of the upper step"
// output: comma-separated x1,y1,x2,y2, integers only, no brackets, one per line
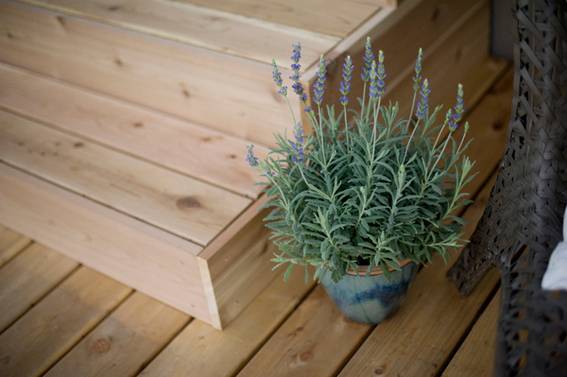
18,0,338,67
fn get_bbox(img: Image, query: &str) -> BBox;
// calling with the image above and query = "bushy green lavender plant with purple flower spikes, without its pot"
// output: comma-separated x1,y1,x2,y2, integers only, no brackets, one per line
246,39,474,281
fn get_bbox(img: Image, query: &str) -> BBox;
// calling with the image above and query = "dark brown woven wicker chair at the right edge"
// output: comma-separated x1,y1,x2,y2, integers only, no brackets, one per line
449,0,567,377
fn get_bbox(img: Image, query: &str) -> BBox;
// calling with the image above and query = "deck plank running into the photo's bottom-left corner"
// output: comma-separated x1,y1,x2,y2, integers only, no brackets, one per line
0,267,131,377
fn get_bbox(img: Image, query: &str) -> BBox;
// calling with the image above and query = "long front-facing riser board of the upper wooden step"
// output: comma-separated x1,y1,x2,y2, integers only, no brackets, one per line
0,2,299,145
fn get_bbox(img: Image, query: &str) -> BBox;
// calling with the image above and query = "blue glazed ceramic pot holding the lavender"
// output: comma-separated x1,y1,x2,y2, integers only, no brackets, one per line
321,260,417,325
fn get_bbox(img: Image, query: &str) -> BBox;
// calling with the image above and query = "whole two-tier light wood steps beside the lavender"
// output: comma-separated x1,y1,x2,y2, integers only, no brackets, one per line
0,0,496,327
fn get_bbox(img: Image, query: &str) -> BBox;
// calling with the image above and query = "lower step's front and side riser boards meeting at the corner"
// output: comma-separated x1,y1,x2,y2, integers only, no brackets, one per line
0,163,276,328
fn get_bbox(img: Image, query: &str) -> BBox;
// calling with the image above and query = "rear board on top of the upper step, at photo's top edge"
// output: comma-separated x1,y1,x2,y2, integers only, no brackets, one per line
181,0,392,38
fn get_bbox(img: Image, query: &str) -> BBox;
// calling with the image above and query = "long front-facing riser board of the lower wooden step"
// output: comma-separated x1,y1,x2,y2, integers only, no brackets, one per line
0,164,210,321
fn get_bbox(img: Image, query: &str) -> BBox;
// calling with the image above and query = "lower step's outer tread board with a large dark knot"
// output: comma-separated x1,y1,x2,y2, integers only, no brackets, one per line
0,111,250,246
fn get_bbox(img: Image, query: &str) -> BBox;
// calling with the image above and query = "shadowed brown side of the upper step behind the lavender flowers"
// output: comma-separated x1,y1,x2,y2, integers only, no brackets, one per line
310,0,496,114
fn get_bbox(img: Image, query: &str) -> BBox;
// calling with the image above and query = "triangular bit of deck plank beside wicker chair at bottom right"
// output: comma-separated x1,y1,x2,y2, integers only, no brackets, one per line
443,291,501,377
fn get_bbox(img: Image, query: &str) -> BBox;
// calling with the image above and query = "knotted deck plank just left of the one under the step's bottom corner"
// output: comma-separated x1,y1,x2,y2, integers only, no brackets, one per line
46,292,190,377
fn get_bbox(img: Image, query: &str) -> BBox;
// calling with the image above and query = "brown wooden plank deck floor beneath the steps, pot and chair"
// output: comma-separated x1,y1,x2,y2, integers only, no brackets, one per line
0,63,512,377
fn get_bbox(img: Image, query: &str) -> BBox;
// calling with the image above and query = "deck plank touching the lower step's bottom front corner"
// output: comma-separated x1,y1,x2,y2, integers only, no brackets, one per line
140,269,313,377
